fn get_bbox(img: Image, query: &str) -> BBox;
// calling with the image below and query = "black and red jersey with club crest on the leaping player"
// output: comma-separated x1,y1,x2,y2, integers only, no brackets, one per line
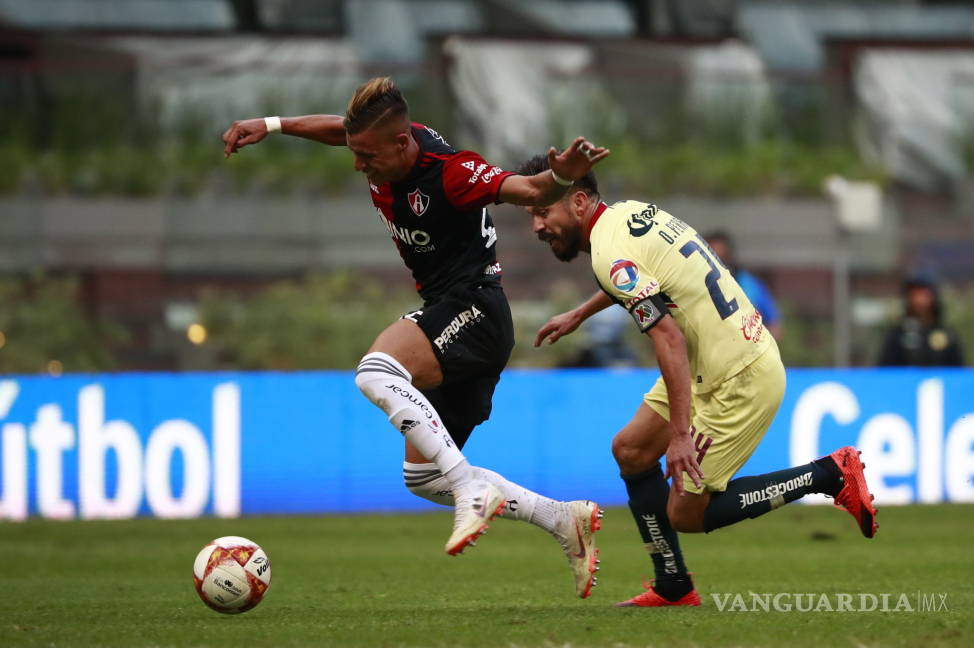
369,122,514,302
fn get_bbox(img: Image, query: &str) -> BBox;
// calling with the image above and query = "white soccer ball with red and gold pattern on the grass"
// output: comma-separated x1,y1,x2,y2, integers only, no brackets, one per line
193,536,271,614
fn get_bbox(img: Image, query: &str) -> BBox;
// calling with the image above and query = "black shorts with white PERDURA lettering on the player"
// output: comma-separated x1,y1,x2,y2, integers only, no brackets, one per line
403,283,514,448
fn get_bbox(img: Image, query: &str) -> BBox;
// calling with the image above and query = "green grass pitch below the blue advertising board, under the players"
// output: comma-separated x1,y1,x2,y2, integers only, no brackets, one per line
0,505,974,648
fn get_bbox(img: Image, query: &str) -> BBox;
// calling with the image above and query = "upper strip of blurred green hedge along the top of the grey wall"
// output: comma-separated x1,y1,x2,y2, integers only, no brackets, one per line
0,137,885,196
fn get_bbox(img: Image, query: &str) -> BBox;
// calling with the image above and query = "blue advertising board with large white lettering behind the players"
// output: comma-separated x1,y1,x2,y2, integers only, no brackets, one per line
0,369,974,520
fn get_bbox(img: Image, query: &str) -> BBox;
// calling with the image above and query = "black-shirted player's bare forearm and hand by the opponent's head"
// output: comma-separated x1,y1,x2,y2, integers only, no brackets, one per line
498,137,609,207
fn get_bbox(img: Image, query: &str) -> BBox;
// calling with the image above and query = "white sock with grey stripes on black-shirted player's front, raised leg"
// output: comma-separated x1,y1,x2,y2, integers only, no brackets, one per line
355,352,473,489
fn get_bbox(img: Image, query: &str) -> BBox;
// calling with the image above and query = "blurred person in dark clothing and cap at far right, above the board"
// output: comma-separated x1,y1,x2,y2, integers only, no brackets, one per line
879,275,964,367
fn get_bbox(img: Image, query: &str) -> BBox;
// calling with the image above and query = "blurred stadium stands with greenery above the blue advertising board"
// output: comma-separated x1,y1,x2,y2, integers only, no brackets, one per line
0,0,974,373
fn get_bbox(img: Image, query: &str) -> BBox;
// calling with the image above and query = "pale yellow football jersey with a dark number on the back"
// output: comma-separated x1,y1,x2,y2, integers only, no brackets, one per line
590,200,772,393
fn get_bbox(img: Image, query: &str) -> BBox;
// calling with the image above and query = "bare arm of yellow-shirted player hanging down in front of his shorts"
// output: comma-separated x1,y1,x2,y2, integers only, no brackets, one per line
648,315,704,495
